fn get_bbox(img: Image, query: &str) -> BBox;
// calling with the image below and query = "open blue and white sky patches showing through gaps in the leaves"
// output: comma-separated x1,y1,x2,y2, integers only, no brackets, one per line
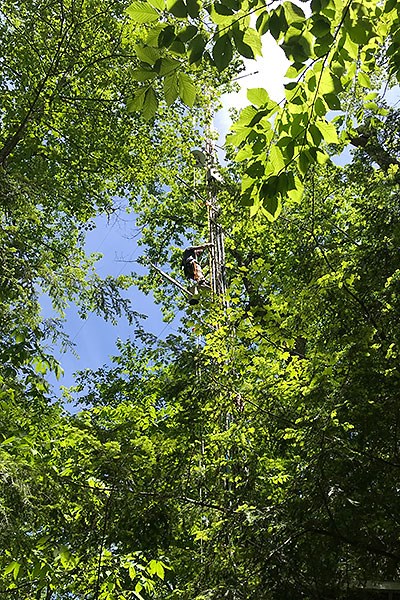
43,36,287,395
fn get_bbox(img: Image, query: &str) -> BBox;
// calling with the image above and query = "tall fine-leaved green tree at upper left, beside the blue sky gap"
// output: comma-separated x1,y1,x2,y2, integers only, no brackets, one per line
0,0,225,384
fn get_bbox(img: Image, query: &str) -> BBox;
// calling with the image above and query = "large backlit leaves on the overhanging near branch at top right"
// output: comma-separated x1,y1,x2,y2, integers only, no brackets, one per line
128,0,400,220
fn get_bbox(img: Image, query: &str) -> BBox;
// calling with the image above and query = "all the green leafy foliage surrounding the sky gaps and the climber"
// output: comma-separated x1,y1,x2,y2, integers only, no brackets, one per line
0,0,400,600
